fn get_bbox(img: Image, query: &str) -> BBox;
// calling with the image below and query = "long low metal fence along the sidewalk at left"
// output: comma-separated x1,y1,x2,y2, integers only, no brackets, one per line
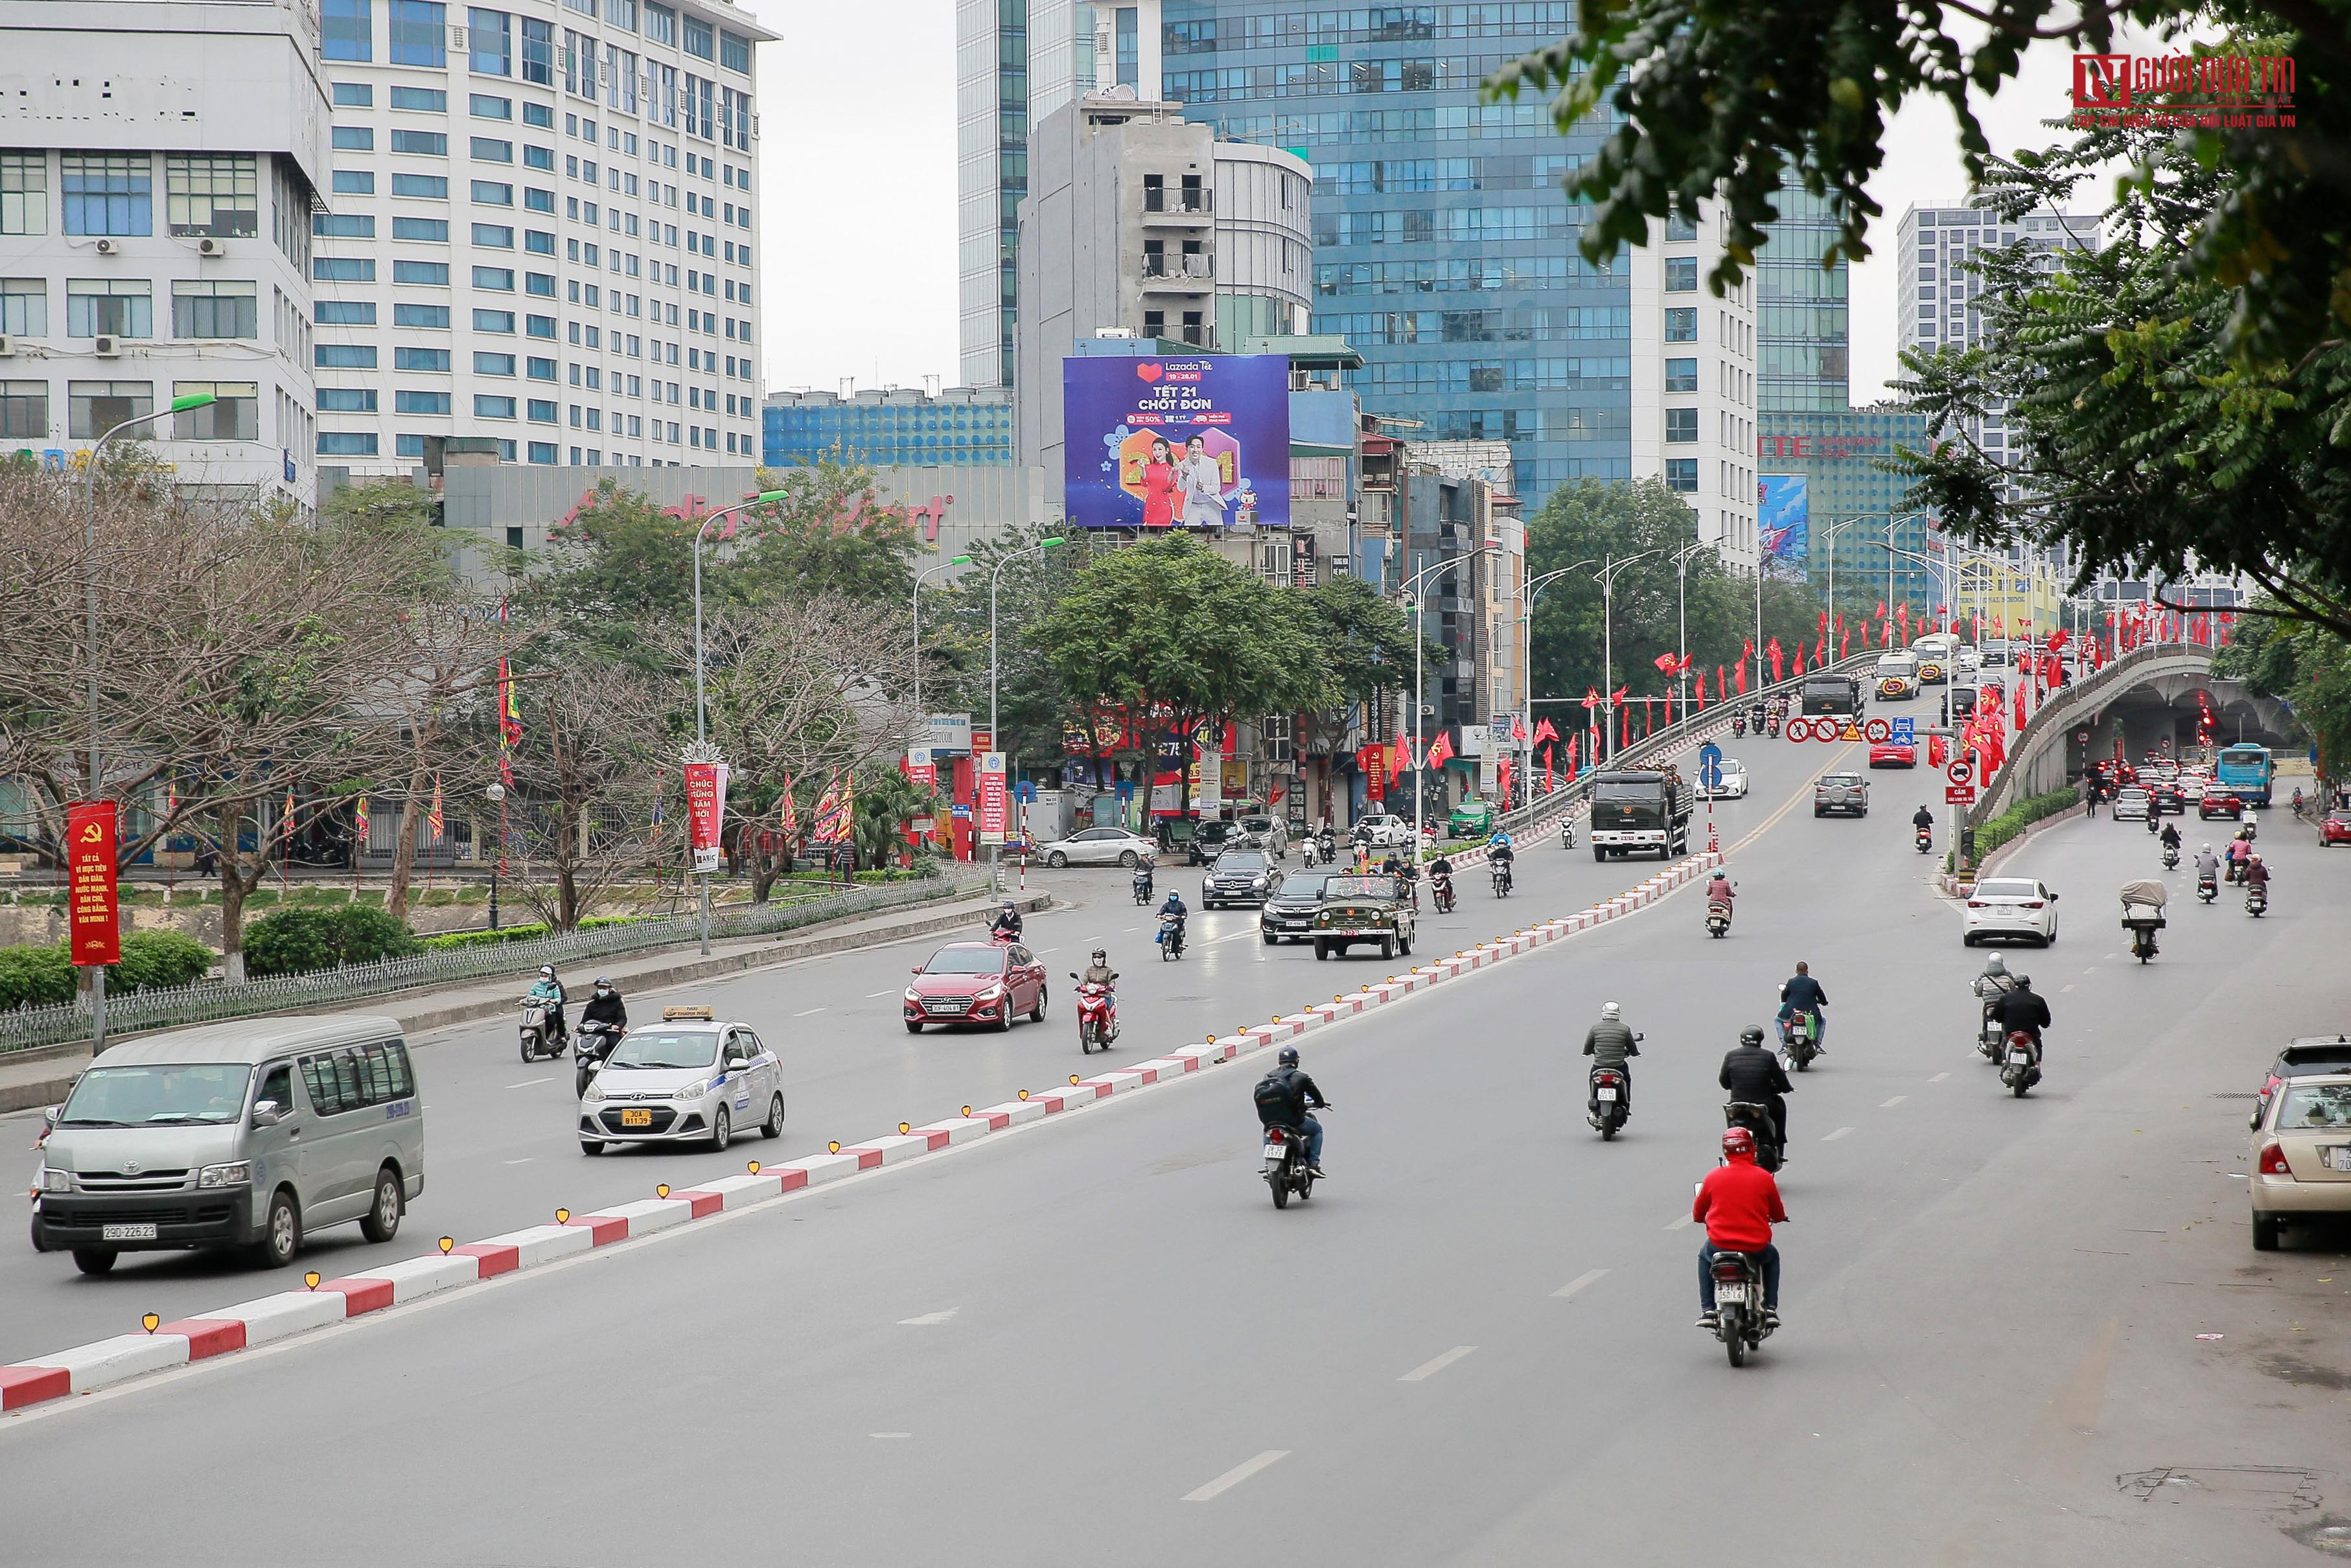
0,868,990,1055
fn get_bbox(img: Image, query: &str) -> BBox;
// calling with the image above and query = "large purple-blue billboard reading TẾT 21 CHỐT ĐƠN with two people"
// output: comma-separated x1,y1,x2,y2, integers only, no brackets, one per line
1060,355,1291,529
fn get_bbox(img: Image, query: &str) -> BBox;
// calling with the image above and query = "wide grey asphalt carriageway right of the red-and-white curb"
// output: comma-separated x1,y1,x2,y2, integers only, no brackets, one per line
0,719,2351,1568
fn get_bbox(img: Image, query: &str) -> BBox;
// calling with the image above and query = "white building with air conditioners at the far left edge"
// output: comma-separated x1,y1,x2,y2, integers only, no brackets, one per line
0,0,327,505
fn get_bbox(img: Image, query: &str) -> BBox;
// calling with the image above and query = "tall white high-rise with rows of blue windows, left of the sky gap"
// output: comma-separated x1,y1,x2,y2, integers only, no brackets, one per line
310,0,776,472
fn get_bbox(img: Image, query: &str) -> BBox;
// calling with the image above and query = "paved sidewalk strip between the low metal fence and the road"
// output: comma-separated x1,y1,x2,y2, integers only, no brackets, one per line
0,894,1051,1114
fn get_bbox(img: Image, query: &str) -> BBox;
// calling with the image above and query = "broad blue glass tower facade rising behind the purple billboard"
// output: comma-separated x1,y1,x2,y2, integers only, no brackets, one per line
1161,0,1632,510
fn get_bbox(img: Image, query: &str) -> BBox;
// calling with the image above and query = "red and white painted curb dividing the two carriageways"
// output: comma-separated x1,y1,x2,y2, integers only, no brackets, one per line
0,851,1723,1411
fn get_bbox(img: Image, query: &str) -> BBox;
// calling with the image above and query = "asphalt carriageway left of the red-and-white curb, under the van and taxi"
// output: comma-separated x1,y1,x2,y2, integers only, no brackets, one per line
0,724,1768,1363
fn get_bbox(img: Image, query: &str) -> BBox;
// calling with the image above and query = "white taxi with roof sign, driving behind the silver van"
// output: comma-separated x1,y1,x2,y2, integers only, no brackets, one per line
578,1006,783,1154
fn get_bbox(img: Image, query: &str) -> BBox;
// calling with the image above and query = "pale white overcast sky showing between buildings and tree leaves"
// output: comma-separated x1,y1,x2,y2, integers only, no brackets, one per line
748,0,2116,407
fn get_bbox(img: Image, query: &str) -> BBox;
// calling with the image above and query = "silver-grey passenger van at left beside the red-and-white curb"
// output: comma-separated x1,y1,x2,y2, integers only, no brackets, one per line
33,1013,426,1274
